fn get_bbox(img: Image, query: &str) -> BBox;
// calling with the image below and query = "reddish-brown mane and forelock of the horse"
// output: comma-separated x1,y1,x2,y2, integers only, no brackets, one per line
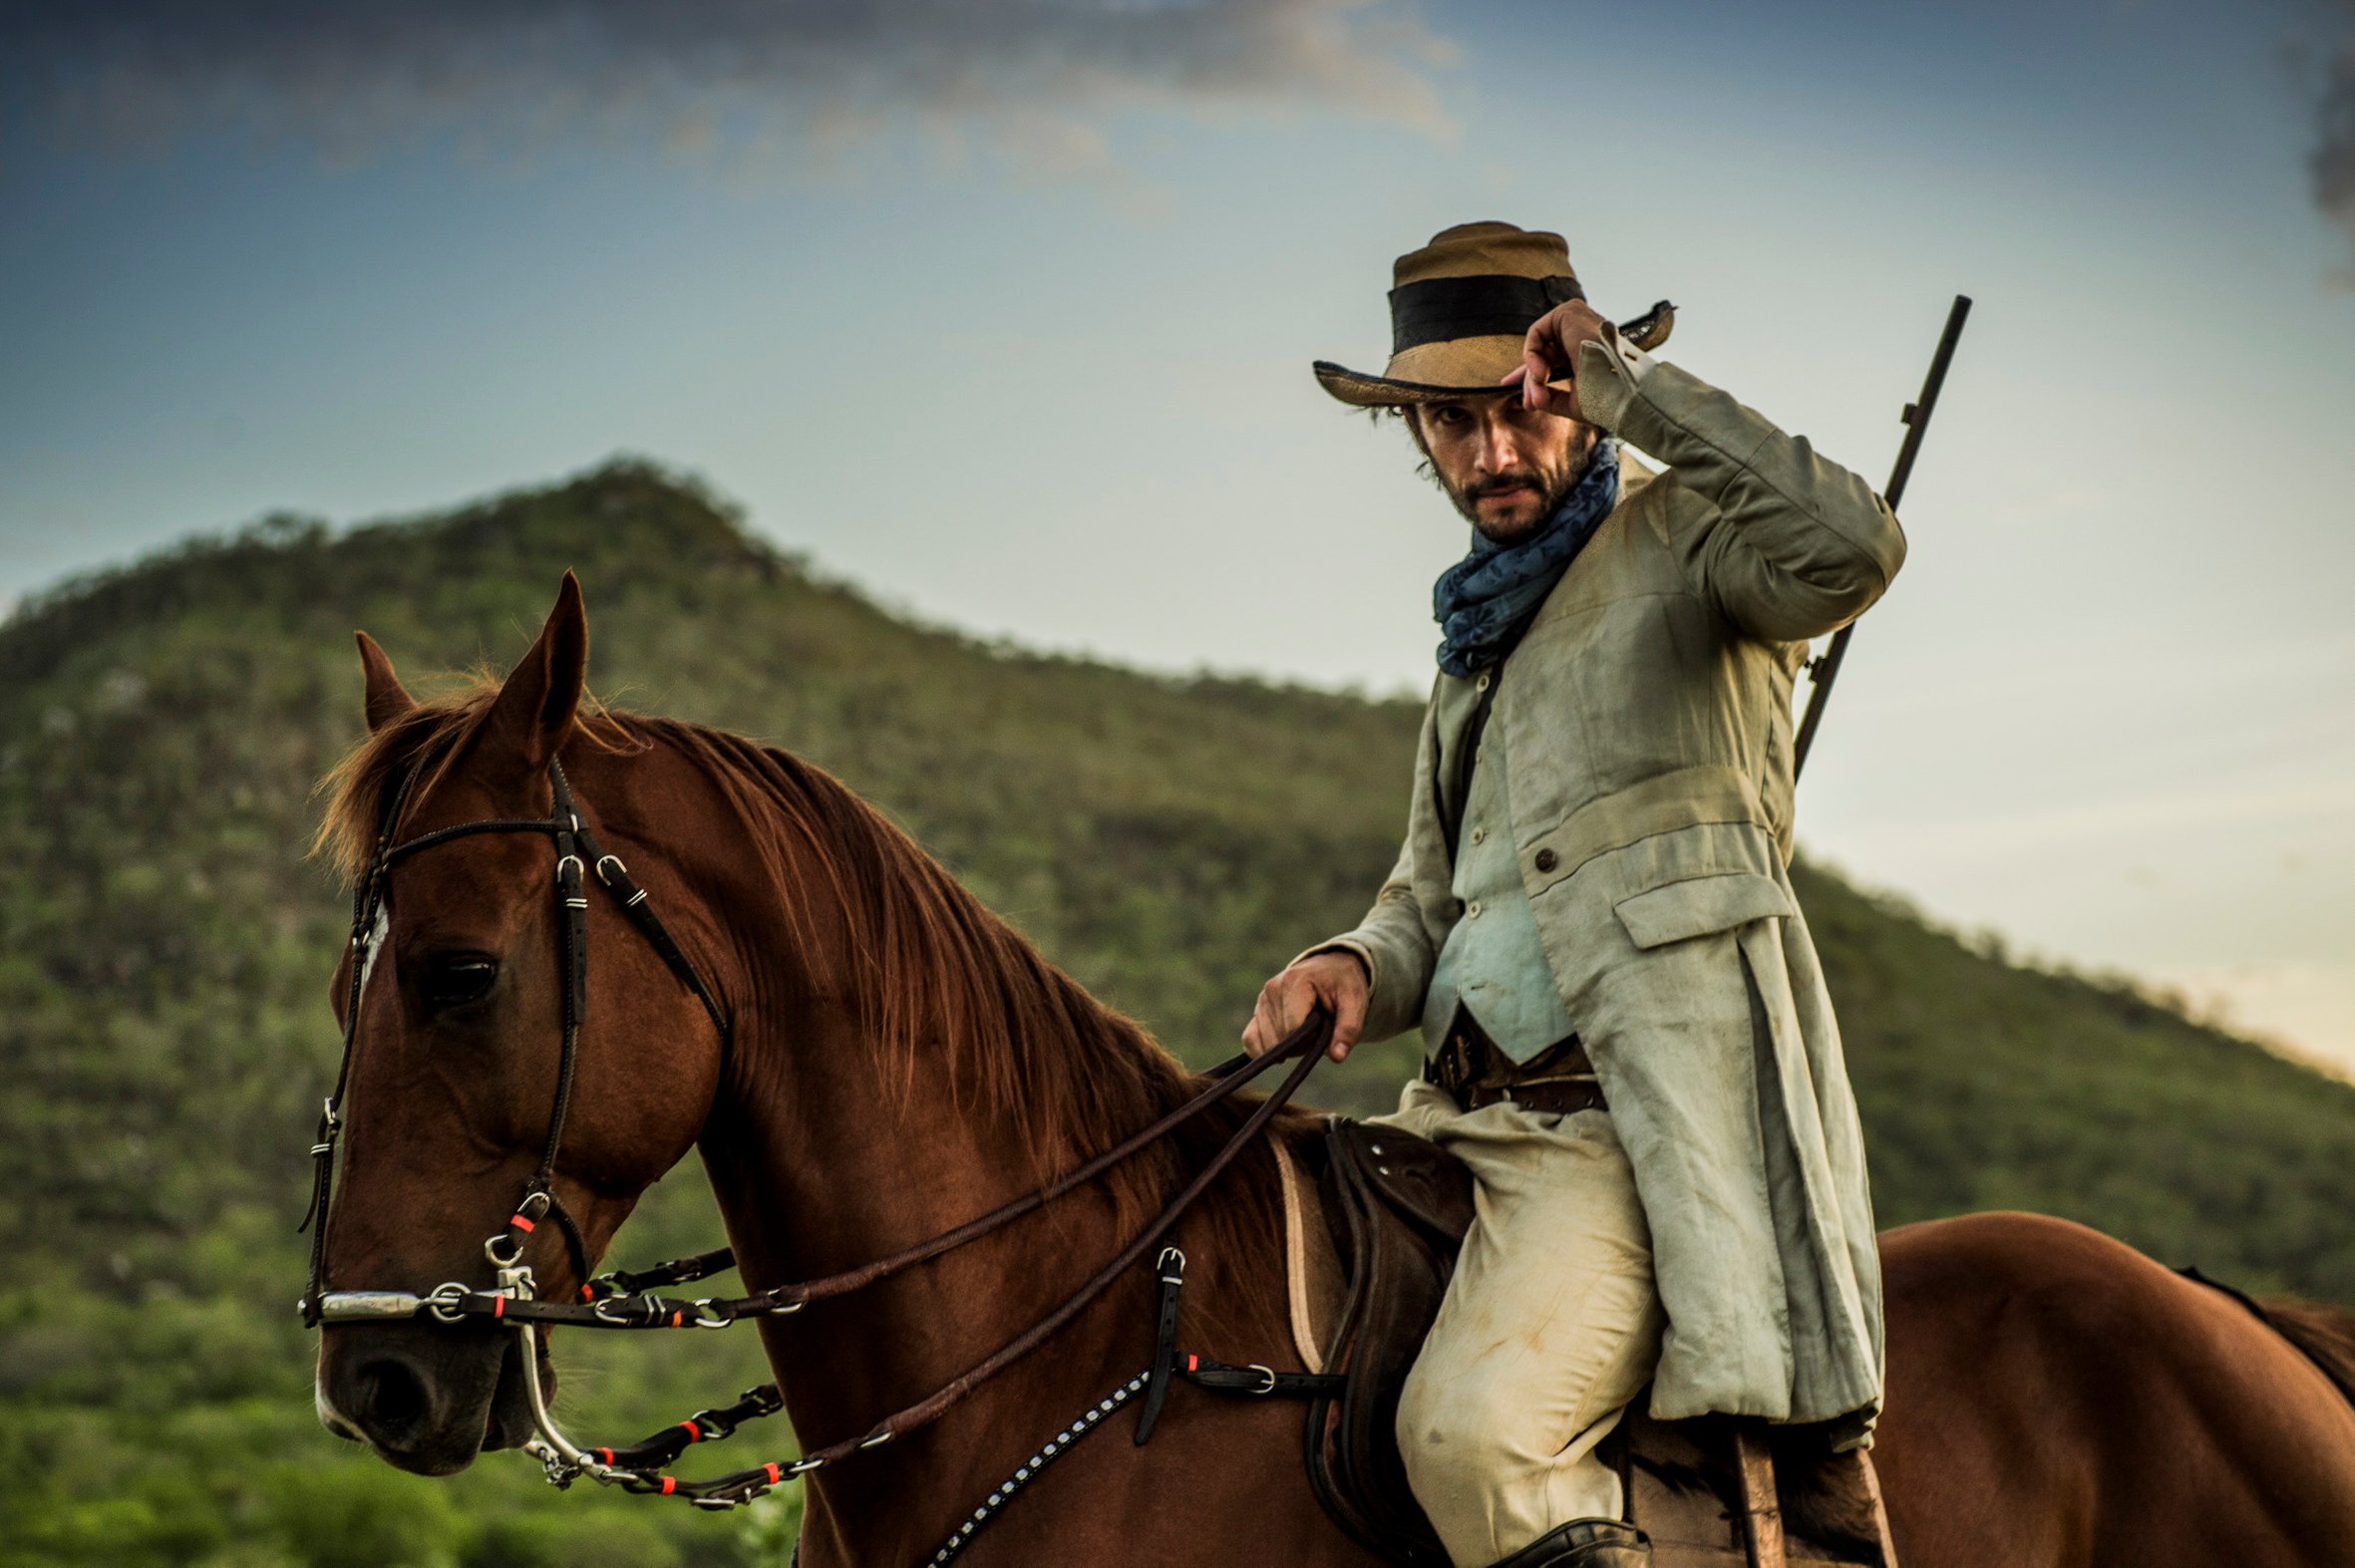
313,676,1300,1290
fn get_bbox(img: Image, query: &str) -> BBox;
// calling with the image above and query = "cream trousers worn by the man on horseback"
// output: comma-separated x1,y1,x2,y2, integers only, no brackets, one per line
1378,1081,1665,1568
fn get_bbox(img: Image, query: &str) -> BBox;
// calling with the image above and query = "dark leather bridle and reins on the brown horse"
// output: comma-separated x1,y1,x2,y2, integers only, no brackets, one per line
297,763,1333,1516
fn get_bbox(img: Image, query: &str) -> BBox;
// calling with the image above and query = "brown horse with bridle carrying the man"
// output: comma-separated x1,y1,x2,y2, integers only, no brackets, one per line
318,577,2355,1568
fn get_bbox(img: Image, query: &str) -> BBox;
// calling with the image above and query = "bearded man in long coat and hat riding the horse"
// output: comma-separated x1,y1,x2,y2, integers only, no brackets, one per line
1243,223,1905,1568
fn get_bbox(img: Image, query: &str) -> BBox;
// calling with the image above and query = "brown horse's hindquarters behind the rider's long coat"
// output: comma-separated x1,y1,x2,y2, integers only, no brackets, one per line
1877,1215,2355,1568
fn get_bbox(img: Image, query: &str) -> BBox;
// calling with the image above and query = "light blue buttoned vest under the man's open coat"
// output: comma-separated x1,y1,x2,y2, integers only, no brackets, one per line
1423,697,1570,1062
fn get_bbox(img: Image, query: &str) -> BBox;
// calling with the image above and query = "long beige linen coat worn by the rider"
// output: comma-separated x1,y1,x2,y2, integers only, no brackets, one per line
1328,344,1905,1422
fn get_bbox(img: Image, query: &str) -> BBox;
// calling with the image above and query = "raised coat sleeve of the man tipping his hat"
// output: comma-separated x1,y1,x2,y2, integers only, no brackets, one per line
1578,344,1905,643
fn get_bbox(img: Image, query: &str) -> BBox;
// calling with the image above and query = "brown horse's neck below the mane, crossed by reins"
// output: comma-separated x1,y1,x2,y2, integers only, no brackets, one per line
640,753,1283,1561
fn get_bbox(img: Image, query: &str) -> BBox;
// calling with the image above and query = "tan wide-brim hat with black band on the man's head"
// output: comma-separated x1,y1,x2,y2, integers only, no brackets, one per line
1316,223,1677,408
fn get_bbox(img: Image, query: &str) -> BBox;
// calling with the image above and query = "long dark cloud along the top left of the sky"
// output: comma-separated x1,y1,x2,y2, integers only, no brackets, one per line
0,0,1444,164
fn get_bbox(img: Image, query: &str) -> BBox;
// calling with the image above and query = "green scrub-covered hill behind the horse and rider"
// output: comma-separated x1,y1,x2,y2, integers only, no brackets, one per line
0,464,2355,1568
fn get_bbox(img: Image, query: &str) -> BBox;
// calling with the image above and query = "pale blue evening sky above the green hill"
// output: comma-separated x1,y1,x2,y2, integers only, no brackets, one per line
13,0,2355,1065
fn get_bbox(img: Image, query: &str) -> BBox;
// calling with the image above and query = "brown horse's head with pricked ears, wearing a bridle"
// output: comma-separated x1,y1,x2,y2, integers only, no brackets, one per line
313,572,721,1474
